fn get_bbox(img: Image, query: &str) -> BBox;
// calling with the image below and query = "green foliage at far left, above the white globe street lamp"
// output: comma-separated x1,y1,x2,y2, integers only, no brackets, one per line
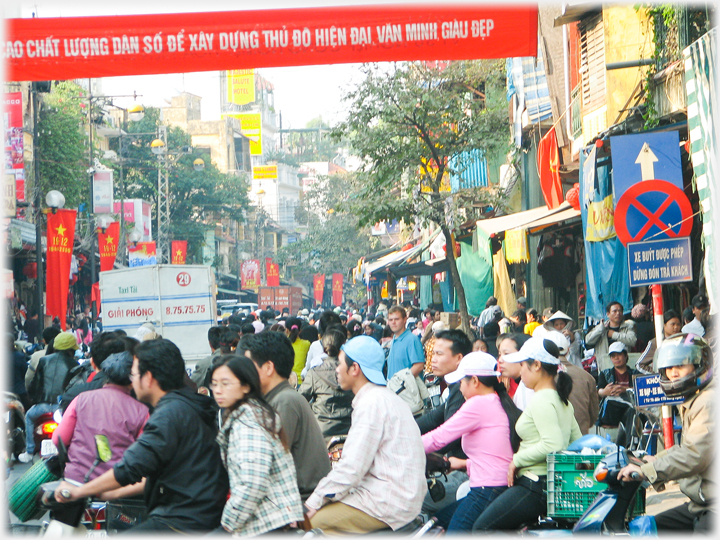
37,81,90,208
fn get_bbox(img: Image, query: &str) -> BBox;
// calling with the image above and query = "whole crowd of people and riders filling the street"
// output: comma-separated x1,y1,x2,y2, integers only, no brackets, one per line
4,296,714,536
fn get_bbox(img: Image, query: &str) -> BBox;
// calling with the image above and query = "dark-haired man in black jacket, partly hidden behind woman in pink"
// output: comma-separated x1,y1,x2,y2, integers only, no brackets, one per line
417,329,472,525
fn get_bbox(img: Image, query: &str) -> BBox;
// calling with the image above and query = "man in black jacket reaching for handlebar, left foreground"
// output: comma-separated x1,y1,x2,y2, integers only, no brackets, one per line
55,339,229,533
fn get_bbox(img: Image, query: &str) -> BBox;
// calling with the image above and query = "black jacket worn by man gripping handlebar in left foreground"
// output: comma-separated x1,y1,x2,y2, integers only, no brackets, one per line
113,388,229,531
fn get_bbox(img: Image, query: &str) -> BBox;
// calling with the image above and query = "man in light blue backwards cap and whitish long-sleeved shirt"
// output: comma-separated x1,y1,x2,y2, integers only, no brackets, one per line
305,335,427,535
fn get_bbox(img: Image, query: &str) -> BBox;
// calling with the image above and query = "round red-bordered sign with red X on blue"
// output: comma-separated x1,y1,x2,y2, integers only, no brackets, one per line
615,180,693,245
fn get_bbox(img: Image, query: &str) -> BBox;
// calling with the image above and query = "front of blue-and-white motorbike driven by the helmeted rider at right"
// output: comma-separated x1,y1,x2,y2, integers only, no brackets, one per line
572,447,645,535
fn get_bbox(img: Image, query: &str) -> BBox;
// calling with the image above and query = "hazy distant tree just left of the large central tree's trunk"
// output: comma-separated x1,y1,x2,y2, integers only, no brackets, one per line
276,171,376,300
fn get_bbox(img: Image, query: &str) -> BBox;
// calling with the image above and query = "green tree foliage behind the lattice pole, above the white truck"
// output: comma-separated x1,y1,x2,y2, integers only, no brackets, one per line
113,109,248,264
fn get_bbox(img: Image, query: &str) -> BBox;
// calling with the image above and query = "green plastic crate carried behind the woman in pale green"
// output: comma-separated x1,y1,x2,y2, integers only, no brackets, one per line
547,454,645,519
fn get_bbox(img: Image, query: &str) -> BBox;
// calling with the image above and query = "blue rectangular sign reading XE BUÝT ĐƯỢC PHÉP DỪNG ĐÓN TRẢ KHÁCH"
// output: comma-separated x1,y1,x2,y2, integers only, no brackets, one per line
627,237,692,287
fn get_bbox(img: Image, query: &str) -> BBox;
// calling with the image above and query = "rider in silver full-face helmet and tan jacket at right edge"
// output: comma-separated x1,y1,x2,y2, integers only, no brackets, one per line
618,333,716,534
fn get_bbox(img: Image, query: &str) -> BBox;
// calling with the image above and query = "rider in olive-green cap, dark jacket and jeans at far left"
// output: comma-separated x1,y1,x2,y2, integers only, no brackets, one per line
18,332,78,463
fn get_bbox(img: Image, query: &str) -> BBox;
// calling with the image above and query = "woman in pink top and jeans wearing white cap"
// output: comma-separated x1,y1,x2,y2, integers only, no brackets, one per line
422,351,521,533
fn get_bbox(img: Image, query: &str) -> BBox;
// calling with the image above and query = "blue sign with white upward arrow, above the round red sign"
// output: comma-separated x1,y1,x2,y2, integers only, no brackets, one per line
610,131,683,203
